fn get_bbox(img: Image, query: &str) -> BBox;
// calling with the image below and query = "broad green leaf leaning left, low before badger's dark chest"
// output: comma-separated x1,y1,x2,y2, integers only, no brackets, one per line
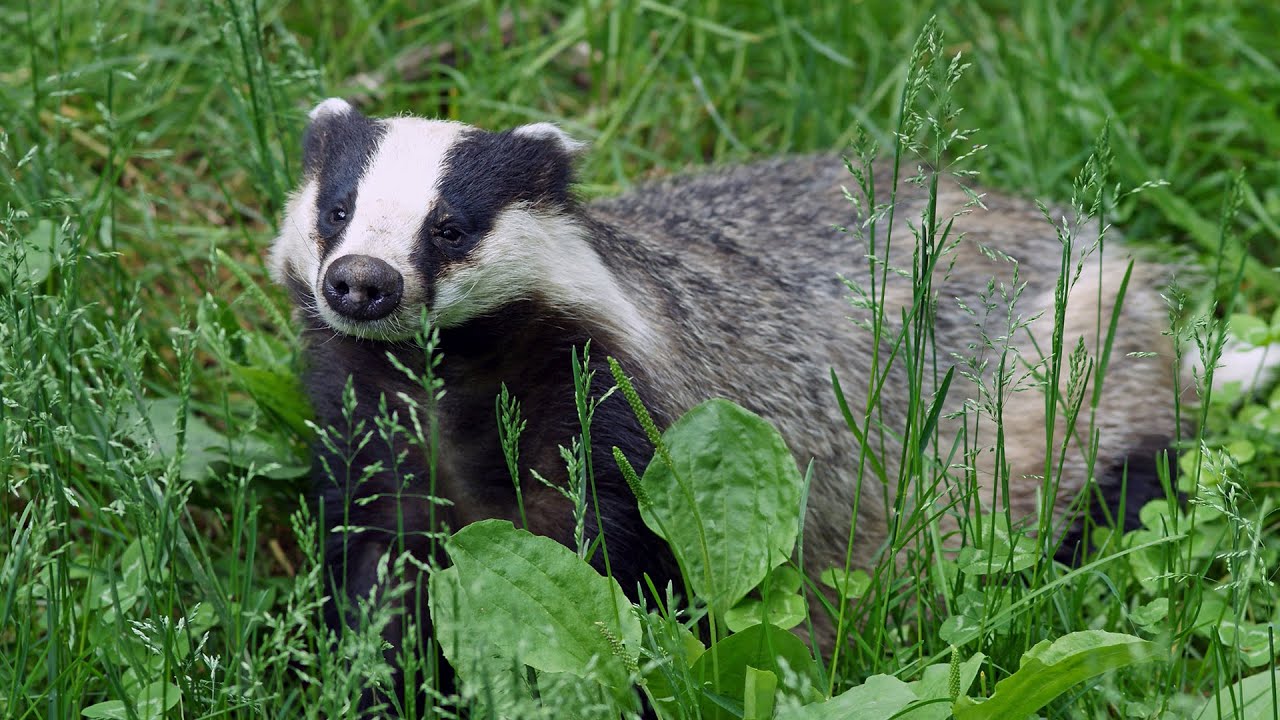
431,520,640,688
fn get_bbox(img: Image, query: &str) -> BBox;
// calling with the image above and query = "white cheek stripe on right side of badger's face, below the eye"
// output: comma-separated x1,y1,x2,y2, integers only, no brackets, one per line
433,205,654,348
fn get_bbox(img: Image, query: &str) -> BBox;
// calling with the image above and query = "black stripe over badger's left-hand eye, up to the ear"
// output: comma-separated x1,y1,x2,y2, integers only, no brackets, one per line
302,103,387,260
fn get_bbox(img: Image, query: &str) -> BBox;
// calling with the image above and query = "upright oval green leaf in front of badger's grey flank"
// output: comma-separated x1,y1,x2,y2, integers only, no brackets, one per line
641,400,803,615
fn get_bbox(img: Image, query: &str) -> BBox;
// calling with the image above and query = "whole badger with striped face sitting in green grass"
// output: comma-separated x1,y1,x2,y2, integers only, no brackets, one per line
269,99,1178,707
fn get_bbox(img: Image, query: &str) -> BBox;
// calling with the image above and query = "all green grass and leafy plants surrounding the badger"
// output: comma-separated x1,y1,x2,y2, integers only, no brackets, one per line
0,0,1280,720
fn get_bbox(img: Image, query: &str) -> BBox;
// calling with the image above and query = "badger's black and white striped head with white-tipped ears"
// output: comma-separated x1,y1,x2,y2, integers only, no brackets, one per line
270,99,591,340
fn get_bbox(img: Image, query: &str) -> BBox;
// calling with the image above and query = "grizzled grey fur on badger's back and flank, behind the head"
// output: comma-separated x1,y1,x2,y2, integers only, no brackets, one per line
589,156,1175,569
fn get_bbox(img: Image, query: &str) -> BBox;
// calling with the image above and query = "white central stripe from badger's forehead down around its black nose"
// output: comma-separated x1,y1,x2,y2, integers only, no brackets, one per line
317,118,466,337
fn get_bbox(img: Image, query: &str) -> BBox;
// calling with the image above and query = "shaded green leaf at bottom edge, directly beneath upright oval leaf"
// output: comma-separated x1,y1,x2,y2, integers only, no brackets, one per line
690,625,814,720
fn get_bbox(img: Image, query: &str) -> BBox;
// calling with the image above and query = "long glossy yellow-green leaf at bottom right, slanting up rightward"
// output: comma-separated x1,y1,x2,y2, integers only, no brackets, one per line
952,630,1156,720
